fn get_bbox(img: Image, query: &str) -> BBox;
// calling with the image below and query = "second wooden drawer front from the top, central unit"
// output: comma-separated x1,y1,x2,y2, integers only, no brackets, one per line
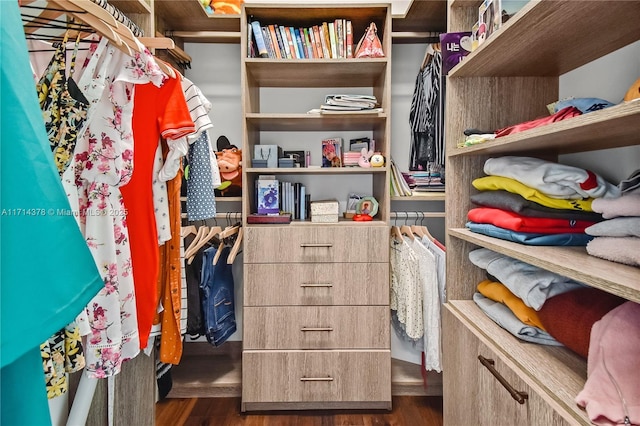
243,263,389,306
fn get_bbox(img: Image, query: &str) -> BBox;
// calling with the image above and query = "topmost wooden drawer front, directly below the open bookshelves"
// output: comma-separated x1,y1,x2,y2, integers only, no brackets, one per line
243,225,389,263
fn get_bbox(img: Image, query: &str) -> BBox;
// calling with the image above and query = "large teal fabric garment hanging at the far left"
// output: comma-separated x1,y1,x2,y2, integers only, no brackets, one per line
0,0,103,425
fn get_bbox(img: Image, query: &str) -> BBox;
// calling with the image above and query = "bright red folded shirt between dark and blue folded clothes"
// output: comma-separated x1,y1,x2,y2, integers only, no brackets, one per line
467,207,595,234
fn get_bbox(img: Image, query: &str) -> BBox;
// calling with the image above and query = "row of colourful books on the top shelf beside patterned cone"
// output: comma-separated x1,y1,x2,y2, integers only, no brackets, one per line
247,19,354,59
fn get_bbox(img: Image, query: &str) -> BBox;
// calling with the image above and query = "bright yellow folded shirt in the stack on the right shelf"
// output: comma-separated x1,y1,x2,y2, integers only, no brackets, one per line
471,175,593,212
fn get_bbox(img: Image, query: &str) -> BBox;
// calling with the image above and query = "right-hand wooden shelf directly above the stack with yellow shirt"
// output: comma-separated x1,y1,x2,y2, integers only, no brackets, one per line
449,101,640,156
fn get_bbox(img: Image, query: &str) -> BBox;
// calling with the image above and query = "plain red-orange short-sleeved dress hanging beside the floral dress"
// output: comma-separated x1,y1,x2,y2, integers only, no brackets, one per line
122,78,195,349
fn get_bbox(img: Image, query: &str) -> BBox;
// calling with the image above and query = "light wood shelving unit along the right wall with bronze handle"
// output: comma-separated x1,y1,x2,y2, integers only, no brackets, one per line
443,0,640,425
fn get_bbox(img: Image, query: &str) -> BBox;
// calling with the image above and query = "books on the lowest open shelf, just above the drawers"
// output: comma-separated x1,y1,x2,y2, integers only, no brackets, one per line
256,175,311,220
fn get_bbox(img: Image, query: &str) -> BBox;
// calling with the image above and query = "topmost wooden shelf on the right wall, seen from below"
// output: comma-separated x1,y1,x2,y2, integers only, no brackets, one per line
449,1,640,78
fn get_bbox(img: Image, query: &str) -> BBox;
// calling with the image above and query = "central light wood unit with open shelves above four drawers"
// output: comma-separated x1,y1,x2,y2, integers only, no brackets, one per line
241,2,391,411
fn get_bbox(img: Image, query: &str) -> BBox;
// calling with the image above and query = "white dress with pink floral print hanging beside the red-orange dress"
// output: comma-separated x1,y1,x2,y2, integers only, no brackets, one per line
63,40,166,378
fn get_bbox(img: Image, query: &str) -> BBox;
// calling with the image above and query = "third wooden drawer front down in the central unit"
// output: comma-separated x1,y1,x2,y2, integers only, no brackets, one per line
242,306,390,349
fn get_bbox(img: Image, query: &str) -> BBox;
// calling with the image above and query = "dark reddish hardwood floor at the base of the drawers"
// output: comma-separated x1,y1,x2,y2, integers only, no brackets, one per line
156,396,442,426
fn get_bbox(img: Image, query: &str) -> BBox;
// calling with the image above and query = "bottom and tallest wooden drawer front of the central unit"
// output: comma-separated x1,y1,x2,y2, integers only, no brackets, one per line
242,350,391,403
